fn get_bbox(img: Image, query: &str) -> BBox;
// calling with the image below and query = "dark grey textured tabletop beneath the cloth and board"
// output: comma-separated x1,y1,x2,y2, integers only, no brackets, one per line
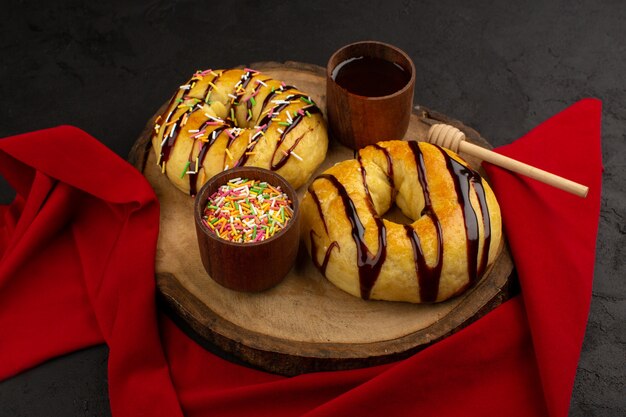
0,0,626,417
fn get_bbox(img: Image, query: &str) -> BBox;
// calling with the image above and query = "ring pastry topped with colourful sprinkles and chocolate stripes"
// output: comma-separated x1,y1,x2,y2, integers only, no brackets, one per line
152,68,328,195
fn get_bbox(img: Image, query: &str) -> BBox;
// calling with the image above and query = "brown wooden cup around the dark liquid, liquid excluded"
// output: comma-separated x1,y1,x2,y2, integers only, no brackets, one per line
326,41,415,149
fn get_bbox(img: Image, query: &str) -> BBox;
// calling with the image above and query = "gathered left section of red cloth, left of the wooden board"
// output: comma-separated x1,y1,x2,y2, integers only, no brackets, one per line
0,126,182,416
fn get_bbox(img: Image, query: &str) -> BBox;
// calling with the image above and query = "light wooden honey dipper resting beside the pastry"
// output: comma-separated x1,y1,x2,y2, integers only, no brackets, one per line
427,123,589,198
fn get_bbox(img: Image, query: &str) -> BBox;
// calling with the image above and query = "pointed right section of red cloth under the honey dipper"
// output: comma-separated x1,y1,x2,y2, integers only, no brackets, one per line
486,99,602,416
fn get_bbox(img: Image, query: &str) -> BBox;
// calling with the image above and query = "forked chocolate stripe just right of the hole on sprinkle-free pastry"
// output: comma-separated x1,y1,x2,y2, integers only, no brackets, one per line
404,141,443,302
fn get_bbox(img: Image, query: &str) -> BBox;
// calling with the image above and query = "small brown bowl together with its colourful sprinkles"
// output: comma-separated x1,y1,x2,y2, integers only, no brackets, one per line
194,167,300,292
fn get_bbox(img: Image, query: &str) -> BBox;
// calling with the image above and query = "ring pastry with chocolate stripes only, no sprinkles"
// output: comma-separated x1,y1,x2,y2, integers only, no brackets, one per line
300,141,502,303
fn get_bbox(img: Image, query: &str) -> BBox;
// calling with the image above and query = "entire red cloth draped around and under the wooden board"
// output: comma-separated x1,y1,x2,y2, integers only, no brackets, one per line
0,99,602,417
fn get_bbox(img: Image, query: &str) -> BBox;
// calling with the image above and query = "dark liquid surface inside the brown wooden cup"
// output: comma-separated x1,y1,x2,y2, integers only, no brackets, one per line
332,56,411,97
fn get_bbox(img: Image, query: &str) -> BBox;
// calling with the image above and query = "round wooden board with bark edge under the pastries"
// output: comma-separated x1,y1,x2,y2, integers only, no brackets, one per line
129,62,513,375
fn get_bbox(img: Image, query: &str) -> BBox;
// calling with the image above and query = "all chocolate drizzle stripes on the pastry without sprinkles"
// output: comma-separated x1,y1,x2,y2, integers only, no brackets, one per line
308,141,491,302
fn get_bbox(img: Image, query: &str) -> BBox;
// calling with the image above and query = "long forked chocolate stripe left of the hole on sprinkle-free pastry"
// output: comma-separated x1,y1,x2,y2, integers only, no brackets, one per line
317,174,387,300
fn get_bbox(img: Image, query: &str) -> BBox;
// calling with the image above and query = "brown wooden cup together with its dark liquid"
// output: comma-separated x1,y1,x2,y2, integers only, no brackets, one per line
326,41,415,149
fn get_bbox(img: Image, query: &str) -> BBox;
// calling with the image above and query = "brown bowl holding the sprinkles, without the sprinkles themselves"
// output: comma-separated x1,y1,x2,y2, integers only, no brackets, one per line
194,167,300,292
